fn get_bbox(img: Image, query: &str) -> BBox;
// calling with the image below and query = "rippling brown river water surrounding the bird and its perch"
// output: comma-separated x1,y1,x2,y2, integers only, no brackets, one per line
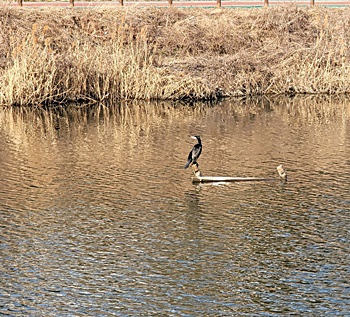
0,98,350,317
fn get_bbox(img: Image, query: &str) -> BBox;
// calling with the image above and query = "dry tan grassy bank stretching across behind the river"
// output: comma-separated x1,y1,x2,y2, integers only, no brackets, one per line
0,5,350,105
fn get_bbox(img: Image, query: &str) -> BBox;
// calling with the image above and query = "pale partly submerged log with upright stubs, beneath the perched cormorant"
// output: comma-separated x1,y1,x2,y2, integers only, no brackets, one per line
192,163,287,183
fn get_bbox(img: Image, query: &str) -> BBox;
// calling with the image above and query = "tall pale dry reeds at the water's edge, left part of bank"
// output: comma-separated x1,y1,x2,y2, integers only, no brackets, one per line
0,14,210,105
